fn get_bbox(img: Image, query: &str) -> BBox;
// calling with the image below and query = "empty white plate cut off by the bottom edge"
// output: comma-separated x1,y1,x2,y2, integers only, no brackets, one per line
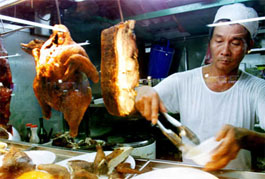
134,167,218,179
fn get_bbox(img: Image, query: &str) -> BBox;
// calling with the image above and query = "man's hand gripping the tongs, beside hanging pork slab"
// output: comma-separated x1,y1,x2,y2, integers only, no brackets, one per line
135,86,167,124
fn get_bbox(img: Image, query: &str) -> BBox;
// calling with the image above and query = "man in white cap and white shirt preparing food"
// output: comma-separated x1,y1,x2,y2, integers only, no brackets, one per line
136,3,265,171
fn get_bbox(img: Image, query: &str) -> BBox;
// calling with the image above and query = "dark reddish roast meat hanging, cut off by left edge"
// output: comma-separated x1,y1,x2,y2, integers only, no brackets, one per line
0,38,13,132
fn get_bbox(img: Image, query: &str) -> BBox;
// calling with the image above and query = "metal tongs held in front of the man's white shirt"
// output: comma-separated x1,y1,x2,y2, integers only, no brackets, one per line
157,112,200,152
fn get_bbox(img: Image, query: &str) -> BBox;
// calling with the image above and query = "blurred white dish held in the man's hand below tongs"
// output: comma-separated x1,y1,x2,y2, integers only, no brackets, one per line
183,137,222,166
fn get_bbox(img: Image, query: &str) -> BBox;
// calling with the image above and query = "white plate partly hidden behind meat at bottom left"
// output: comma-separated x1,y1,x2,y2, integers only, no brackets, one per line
0,150,56,166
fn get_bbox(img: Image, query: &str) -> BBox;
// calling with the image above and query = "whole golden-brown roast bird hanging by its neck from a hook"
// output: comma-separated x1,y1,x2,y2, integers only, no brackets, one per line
21,25,99,137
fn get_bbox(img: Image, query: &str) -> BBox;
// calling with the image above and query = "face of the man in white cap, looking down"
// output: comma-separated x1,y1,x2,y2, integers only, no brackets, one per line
210,24,248,73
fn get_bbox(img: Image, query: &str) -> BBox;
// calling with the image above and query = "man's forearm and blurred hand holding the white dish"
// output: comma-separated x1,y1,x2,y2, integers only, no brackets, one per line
204,125,265,171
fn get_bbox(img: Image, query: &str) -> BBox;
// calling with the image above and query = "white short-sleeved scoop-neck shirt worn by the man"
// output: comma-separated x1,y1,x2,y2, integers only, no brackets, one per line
154,67,265,170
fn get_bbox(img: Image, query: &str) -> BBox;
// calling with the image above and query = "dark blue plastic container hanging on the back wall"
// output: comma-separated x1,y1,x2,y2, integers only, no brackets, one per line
148,40,175,78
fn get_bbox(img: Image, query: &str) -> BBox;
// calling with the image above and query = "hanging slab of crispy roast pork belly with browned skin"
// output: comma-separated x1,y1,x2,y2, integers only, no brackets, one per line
101,20,139,116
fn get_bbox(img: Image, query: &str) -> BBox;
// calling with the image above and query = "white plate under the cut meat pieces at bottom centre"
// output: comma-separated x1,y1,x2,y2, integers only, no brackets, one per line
56,151,135,178
